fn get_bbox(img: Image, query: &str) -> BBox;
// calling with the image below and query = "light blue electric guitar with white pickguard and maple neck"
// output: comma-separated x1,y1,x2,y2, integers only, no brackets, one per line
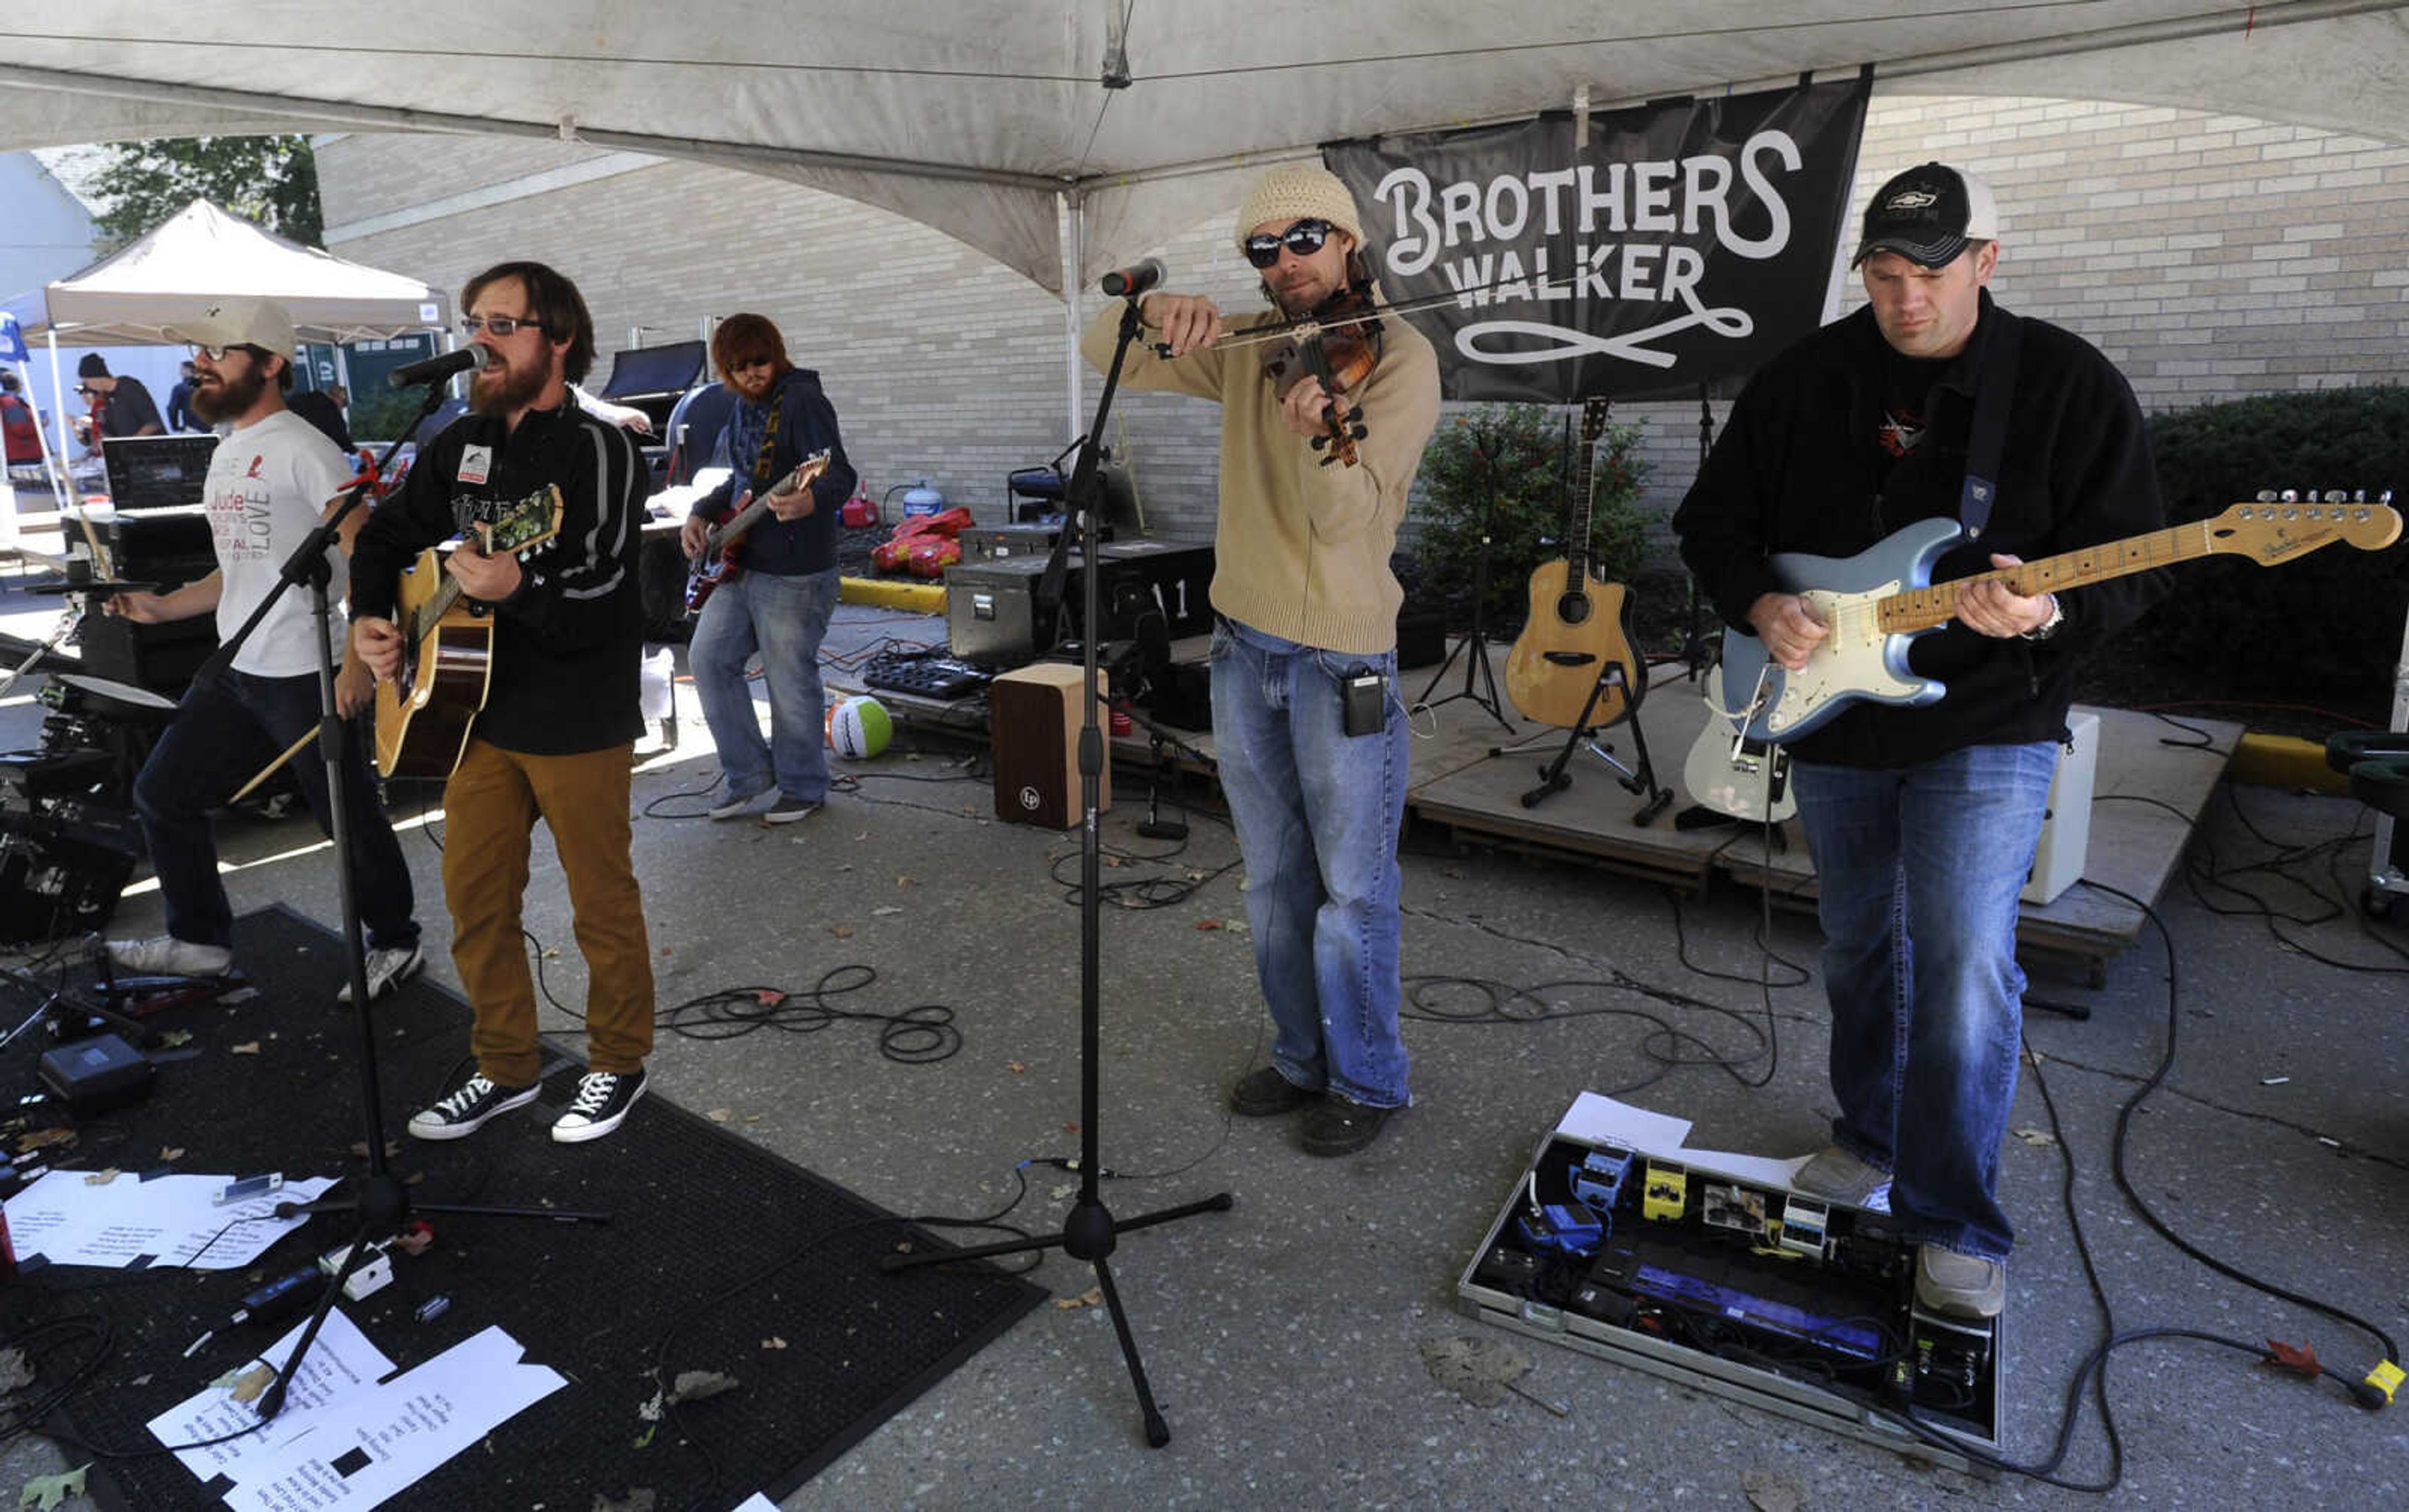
1723,494,2401,744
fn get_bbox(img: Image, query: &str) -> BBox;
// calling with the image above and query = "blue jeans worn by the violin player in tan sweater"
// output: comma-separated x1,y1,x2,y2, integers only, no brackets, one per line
1212,619,1412,1107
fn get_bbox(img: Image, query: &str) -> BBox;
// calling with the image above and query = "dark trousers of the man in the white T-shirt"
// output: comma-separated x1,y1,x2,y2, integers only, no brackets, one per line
135,667,419,951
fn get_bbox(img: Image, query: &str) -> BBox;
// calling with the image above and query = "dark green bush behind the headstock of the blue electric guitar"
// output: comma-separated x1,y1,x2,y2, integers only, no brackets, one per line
2139,388,2409,703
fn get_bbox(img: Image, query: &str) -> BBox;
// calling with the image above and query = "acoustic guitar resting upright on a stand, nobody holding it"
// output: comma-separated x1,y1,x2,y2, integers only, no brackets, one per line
1506,400,1648,730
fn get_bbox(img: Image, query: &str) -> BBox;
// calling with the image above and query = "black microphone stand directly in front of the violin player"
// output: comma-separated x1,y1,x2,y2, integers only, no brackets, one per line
880,279,1231,1449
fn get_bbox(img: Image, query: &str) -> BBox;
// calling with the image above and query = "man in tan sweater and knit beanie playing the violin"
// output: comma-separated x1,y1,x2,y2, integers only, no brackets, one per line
1079,164,1438,1156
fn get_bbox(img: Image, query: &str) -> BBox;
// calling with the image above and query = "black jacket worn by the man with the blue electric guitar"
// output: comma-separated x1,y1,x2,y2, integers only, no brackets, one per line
1672,291,2168,768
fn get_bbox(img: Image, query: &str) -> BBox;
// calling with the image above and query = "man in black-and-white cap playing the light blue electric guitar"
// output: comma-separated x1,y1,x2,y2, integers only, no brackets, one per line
1672,164,2166,1319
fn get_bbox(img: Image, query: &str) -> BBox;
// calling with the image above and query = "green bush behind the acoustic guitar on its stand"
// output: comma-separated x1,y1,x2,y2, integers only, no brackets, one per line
1417,405,1648,636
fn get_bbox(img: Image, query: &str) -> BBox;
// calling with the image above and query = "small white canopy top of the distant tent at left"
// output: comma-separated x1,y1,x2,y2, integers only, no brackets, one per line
8,200,448,347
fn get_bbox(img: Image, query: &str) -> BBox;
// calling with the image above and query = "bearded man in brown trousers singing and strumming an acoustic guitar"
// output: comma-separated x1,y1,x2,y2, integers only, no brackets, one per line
352,262,653,1141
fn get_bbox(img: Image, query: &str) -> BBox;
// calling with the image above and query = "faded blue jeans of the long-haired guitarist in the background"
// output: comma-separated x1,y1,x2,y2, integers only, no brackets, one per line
686,568,838,804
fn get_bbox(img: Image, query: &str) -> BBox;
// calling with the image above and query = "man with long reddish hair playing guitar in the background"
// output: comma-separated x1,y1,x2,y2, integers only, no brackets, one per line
679,316,855,823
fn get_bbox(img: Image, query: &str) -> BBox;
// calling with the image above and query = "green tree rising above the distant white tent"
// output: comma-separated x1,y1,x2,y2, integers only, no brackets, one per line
92,137,325,245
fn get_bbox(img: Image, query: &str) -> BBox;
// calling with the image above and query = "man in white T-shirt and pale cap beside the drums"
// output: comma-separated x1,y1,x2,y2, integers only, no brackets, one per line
109,299,424,1001
